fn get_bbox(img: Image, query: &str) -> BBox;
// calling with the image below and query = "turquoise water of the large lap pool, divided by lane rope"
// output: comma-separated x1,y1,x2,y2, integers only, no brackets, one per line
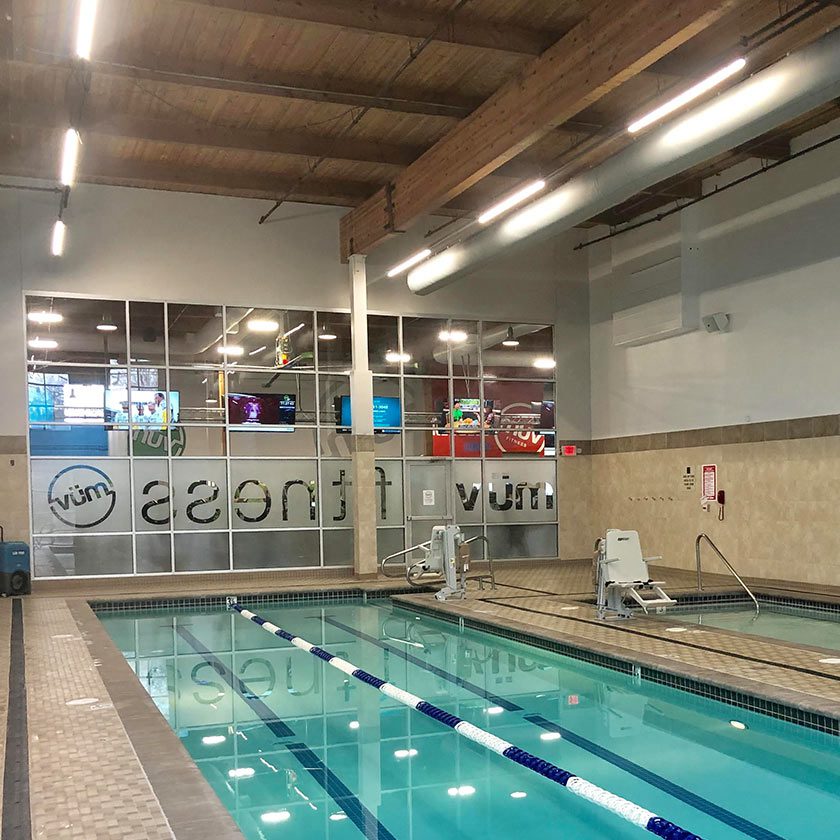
100,602,840,840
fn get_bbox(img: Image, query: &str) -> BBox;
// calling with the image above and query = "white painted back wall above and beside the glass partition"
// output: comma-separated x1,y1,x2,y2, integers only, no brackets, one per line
0,185,589,437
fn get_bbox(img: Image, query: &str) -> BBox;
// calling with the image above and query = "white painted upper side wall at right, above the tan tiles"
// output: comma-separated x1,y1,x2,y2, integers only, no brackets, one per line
588,121,840,438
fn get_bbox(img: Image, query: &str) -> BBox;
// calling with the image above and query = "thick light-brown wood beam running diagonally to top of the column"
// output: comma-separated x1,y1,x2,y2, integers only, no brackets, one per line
340,0,743,259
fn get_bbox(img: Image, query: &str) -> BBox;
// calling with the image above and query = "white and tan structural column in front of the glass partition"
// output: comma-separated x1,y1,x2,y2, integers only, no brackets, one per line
350,254,377,575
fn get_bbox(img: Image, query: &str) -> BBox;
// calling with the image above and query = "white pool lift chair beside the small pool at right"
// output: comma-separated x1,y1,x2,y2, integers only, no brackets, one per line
595,528,677,618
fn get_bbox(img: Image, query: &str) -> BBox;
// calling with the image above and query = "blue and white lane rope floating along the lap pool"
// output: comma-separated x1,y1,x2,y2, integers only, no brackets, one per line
228,598,702,840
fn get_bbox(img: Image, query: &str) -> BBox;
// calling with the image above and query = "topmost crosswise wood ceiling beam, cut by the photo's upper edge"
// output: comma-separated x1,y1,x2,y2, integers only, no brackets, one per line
179,0,559,55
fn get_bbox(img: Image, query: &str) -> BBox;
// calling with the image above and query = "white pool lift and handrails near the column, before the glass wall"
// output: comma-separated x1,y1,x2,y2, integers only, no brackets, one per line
379,525,496,601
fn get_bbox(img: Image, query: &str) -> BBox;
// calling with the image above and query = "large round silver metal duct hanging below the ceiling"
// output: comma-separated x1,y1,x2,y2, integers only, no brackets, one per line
408,29,840,295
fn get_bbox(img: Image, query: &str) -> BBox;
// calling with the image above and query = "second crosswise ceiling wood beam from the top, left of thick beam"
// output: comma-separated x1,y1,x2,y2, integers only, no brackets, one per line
13,50,481,119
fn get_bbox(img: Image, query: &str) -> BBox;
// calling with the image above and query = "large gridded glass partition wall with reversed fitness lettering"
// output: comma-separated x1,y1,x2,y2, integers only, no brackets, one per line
26,295,557,578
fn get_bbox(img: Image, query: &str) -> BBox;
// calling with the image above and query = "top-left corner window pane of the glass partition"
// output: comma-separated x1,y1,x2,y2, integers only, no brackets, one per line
26,296,127,365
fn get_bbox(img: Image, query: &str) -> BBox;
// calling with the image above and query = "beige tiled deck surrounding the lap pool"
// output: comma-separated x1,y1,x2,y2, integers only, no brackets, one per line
0,561,840,840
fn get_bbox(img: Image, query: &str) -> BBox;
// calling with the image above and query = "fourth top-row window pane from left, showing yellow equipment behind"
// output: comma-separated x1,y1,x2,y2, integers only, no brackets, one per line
225,306,315,370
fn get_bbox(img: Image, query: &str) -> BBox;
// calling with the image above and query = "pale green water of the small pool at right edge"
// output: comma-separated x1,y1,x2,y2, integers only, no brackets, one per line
668,603,840,650
